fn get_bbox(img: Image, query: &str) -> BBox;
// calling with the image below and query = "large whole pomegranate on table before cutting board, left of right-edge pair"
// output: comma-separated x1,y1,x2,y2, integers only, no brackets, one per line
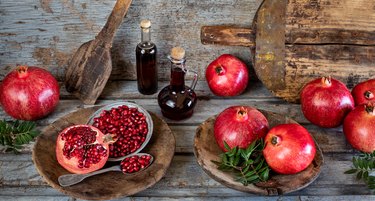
300,77,354,128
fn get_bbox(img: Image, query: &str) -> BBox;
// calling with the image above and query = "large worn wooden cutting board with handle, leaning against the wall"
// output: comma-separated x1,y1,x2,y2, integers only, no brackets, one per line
201,0,375,102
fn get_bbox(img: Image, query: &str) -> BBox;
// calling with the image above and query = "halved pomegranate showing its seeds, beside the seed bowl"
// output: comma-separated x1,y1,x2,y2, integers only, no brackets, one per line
56,125,112,174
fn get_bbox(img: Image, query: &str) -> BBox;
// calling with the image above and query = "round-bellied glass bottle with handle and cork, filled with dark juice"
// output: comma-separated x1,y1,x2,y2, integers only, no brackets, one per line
158,47,198,120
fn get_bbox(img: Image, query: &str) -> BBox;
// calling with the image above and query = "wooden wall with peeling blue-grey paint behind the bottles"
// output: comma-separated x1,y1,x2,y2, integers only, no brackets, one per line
0,0,261,81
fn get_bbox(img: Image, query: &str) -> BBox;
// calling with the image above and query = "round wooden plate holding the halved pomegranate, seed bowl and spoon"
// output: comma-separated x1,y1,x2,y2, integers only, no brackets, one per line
32,107,176,200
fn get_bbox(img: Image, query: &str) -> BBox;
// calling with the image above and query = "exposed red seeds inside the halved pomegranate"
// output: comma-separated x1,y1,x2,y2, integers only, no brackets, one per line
61,127,107,168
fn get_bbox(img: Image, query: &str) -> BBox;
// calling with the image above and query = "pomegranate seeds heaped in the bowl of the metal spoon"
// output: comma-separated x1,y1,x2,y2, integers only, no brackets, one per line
120,155,151,173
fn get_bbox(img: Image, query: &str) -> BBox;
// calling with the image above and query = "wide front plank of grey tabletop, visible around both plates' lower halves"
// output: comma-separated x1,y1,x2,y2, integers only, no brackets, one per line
0,154,370,197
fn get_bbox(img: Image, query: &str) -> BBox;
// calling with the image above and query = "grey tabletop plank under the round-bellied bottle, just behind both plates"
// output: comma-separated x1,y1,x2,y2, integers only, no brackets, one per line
0,98,309,125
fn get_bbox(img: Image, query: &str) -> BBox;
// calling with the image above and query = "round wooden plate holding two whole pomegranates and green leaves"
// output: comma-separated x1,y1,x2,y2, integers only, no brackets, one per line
194,110,323,195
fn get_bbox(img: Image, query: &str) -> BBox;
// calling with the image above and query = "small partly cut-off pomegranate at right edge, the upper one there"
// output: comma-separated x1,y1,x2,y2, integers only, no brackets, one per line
352,79,375,105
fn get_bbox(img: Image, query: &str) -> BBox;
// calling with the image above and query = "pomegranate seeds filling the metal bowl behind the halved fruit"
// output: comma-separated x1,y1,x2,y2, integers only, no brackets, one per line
93,105,148,158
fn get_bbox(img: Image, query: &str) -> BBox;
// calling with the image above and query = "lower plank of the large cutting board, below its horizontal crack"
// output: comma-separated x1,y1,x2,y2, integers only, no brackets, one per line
276,45,375,100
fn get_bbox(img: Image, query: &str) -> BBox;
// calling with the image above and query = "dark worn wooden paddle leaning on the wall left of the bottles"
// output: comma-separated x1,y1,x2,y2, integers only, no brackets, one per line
65,0,132,105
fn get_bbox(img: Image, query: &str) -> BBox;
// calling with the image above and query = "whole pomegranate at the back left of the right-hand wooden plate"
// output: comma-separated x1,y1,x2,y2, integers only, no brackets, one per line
214,106,269,152
